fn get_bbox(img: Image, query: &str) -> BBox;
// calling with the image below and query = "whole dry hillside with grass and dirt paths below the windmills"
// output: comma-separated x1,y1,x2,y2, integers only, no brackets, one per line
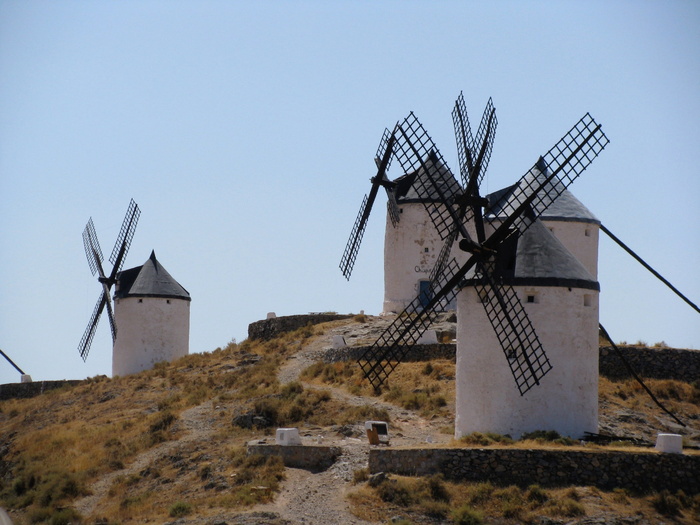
0,316,700,524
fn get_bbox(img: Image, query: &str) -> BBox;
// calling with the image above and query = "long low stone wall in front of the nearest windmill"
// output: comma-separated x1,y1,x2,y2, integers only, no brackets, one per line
369,448,700,494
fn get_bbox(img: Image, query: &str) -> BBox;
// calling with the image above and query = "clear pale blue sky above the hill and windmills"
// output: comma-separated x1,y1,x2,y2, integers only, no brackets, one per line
0,0,700,383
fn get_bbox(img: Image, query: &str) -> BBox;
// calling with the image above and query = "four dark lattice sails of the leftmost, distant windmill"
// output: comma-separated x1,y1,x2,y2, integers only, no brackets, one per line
78,199,141,361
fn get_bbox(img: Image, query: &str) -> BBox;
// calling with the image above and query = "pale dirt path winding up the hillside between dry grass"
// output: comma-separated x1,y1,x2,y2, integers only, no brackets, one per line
74,318,450,525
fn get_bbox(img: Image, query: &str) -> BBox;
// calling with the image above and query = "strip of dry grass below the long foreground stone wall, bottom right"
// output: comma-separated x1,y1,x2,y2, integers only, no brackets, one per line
349,476,700,524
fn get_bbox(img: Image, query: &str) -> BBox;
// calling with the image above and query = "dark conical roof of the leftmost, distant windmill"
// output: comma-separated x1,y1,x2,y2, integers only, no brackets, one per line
114,251,191,301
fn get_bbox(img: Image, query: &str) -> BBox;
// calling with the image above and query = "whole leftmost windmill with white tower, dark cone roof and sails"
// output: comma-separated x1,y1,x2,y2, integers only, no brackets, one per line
78,199,190,376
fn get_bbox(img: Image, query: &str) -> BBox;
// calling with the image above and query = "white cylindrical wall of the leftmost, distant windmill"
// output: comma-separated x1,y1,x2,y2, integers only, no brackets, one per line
112,297,190,376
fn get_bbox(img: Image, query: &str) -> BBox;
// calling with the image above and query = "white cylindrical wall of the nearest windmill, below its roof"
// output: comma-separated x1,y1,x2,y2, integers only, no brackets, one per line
455,287,598,439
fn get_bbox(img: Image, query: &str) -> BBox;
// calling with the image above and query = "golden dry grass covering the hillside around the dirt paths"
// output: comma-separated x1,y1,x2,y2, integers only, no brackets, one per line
0,319,700,523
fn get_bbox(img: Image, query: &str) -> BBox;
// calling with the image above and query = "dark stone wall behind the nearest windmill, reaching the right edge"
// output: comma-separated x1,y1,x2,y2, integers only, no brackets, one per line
599,346,700,382
